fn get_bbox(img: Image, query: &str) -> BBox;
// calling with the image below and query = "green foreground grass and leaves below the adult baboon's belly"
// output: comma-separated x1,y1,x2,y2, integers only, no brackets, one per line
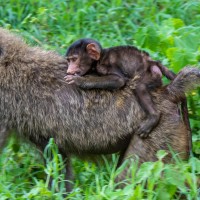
0,137,200,200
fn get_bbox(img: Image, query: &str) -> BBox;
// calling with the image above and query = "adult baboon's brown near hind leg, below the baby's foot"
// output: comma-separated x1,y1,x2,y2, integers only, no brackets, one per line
117,119,189,181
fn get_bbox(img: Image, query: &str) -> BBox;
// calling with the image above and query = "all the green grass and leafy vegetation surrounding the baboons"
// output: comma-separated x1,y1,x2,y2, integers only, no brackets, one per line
0,0,200,200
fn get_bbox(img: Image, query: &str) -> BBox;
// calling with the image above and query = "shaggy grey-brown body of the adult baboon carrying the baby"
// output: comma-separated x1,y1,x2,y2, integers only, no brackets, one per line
0,28,199,191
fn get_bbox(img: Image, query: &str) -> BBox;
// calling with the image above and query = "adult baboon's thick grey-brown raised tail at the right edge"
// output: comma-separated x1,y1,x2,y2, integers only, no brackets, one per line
167,67,200,103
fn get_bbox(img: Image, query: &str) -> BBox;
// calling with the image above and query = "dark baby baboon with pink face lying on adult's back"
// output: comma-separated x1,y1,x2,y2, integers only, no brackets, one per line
66,38,176,138
